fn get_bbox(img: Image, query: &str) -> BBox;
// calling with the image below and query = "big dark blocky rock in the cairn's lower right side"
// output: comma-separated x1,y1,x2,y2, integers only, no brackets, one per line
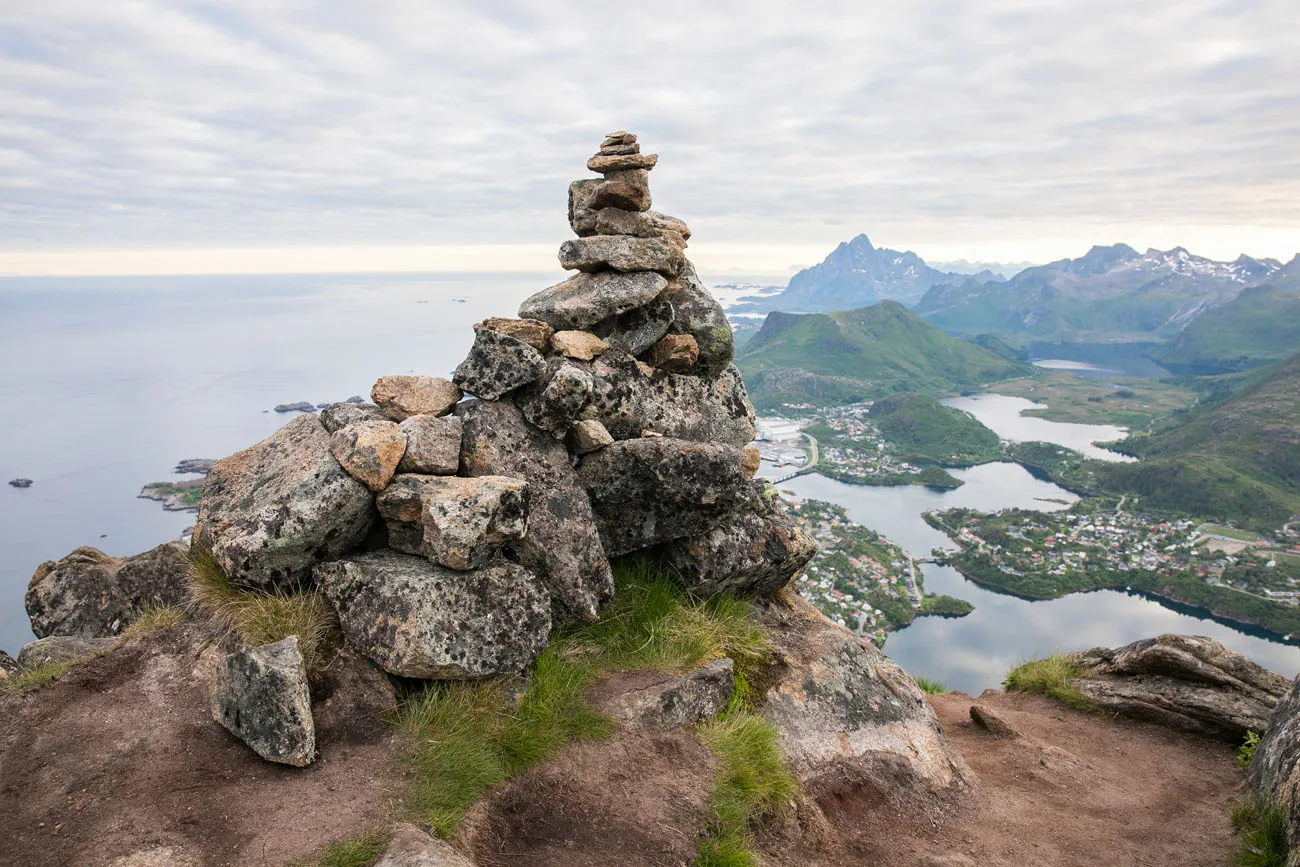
577,437,759,556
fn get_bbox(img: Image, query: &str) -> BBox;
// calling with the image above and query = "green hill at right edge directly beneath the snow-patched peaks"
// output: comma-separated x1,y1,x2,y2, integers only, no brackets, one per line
1148,286,1300,376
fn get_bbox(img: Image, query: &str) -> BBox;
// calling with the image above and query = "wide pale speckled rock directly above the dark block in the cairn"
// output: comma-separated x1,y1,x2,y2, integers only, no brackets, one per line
579,350,755,448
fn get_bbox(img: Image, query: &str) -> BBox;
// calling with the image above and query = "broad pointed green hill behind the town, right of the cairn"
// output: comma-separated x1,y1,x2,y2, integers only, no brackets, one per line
737,302,1030,409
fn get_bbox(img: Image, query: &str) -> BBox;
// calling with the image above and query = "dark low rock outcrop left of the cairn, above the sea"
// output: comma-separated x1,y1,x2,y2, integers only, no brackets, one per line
23,542,189,638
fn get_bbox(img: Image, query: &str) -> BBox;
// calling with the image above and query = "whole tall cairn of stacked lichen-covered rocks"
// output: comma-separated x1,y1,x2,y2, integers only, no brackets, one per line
185,131,816,764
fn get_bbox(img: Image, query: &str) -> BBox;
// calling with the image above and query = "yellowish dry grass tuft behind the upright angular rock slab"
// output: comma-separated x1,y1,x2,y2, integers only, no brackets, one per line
190,547,342,676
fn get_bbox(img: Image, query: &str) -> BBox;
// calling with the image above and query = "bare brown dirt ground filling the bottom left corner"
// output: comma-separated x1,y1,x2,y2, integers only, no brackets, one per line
0,627,399,867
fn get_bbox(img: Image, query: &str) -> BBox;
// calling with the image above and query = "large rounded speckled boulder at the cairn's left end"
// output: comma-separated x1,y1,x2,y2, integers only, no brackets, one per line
194,416,374,588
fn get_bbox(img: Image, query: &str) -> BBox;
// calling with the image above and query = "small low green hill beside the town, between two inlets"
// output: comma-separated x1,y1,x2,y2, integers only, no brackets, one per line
867,394,1002,467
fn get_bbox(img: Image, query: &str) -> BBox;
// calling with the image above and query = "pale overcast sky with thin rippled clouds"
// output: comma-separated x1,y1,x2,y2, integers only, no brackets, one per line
0,0,1300,273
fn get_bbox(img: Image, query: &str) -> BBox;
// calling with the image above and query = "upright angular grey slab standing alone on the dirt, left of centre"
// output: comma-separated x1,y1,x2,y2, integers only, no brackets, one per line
208,636,316,768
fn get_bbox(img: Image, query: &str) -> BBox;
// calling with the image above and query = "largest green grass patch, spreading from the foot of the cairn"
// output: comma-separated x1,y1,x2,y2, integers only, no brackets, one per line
400,560,767,837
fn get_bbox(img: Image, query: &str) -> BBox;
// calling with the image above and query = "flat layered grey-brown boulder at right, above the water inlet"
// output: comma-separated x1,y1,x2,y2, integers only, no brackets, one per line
1070,634,1287,744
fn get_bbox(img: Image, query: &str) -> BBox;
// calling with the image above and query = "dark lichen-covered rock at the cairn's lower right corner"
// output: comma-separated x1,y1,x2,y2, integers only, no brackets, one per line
664,510,818,597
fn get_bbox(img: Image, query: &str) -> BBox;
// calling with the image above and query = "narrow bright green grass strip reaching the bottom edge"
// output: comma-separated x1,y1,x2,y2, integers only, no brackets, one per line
696,711,798,867
